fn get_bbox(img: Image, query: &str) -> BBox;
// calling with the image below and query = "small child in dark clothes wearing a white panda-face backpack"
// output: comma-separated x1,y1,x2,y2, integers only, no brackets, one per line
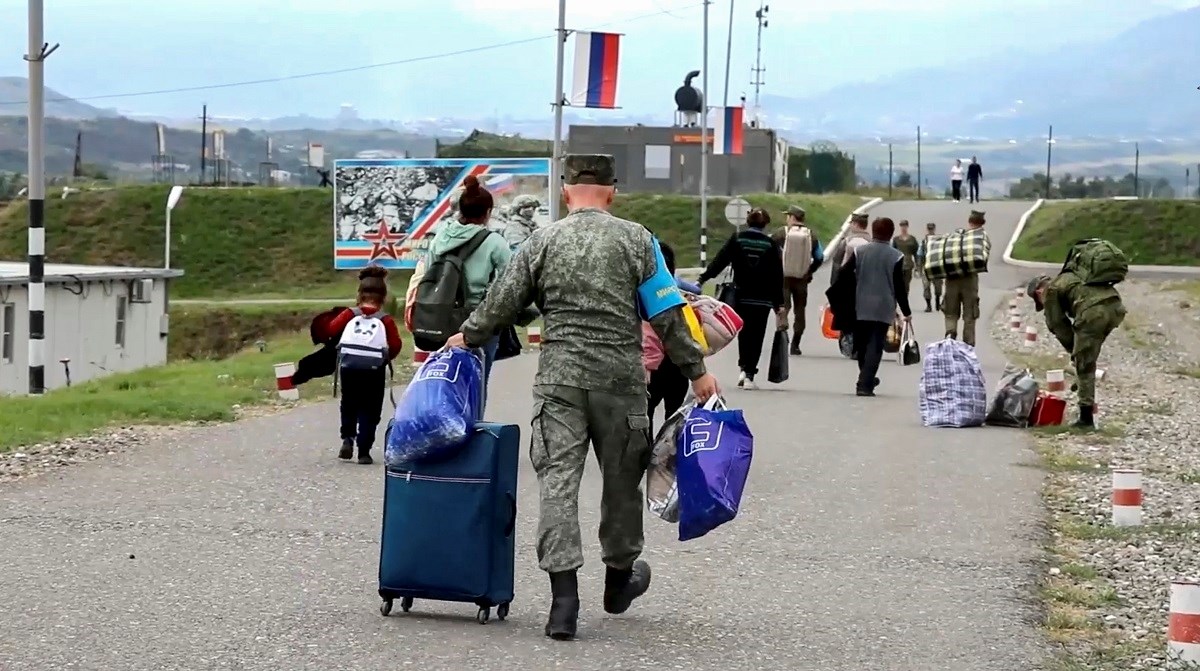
326,265,403,463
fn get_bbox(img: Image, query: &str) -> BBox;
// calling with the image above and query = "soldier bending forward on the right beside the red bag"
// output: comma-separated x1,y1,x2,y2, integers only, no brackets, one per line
1025,270,1126,429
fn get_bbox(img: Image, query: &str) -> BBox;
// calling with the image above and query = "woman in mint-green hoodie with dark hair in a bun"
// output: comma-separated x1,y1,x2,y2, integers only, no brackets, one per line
408,175,512,400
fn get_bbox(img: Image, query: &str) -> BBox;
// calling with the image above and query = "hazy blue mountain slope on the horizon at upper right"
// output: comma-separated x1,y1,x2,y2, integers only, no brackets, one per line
764,7,1200,137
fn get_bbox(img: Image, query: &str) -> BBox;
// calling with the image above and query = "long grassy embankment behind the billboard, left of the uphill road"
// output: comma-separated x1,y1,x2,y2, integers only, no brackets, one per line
0,186,862,298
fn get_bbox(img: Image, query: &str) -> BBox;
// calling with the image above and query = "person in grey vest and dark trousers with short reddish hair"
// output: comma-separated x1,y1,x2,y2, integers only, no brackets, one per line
844,217,912,396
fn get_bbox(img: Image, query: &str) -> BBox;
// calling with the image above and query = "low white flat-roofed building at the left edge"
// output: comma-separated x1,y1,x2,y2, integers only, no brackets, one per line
0,262,184,394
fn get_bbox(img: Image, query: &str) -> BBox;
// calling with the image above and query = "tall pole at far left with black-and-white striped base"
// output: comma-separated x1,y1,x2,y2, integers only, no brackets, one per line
25,0,59,396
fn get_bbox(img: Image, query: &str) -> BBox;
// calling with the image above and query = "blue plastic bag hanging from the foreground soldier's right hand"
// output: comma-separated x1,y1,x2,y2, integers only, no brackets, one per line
676,396,754,540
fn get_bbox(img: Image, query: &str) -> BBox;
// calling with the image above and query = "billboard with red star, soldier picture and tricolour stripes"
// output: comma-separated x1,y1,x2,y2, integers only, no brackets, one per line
334,158,550,270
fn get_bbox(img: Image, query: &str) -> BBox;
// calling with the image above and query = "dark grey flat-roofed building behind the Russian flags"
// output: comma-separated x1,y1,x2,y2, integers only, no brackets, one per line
566,125,788,196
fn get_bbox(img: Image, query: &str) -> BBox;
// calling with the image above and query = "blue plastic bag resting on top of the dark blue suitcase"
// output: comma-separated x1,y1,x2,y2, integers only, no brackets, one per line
384,348,484,466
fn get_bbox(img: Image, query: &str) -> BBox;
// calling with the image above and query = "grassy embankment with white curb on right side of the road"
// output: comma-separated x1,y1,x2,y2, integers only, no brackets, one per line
1013,200,1200,265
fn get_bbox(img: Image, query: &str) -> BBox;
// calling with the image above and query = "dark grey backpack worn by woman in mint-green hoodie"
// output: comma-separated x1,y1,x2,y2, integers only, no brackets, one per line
412,229,492,352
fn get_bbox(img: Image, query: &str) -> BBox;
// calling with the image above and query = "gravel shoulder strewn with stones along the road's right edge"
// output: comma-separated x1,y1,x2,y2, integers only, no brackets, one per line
992,281,1200,671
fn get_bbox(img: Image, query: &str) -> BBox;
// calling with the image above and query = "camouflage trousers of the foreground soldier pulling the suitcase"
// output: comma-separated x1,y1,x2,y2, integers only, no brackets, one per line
529,384,650,573
